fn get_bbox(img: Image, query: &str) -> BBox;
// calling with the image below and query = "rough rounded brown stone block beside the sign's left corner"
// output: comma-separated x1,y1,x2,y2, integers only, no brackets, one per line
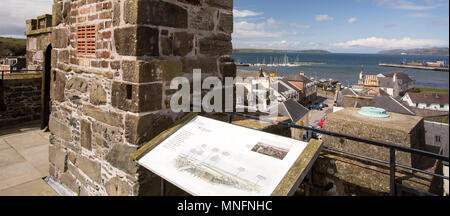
105,144,137,174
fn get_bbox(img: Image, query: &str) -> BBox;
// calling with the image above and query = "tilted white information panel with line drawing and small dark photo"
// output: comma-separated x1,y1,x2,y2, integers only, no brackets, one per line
138,116,308,196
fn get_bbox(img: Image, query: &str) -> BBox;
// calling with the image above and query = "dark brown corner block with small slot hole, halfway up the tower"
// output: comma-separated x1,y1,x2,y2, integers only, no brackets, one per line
111,82,162,112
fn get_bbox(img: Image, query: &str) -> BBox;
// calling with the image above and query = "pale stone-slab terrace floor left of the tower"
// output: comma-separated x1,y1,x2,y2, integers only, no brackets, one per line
0,121,58,196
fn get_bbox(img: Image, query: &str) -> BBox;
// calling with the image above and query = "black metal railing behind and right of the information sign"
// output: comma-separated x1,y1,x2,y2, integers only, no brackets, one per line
225,112,449,196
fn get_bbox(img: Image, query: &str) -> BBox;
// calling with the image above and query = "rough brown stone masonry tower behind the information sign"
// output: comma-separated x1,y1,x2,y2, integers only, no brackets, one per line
49,0,236,195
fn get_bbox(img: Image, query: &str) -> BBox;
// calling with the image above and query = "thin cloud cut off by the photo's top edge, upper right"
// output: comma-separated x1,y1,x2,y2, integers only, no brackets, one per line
373,0,441,10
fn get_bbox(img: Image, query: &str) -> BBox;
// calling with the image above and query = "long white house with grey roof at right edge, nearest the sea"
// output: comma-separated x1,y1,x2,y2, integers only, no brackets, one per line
402,92,449,112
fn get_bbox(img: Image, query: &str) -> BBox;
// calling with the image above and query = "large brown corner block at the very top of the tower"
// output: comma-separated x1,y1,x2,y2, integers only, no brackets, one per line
124,0,188,28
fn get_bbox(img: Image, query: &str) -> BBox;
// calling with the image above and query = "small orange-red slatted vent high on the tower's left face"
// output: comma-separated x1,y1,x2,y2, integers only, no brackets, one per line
77,25,97,55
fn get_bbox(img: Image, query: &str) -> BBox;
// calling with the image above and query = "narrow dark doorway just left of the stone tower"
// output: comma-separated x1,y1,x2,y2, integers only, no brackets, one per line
41,44,52,130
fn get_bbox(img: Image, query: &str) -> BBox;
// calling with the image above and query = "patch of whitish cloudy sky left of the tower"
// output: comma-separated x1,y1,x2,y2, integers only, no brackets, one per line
0,0,53,37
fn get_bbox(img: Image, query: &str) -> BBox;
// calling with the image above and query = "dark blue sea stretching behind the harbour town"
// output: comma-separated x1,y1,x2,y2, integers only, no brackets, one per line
232,53,449,89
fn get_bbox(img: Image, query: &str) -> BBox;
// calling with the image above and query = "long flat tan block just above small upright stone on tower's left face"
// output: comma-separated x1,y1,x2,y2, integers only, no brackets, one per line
83,105,123,127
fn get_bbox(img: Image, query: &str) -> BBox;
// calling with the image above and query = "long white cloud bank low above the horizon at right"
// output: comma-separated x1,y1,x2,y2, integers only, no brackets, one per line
332,37,448,49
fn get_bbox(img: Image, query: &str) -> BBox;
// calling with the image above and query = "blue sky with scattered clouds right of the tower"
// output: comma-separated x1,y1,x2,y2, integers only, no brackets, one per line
233,0,449,53
